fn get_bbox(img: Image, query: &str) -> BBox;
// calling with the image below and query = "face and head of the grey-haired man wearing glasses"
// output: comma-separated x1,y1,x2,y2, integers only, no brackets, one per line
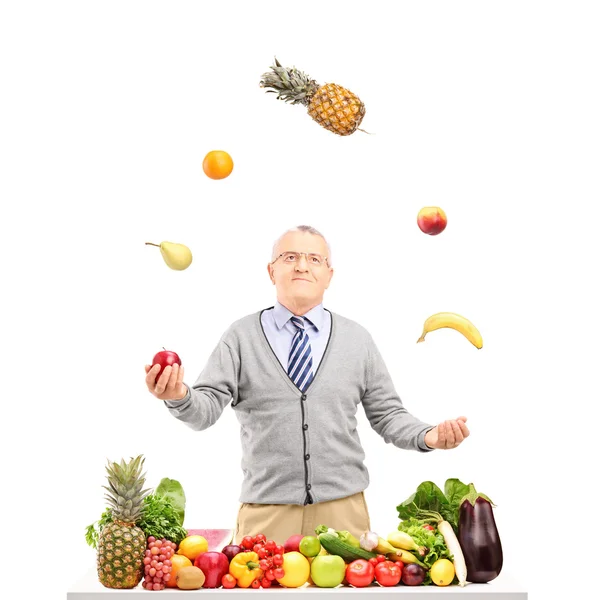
268,231,333,306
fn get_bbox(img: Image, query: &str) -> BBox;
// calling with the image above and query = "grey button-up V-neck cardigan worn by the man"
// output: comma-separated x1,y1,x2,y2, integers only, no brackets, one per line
165,311,433,504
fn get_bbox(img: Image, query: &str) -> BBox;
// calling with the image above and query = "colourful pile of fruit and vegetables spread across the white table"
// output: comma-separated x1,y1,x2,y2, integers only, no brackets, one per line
86,455,502,591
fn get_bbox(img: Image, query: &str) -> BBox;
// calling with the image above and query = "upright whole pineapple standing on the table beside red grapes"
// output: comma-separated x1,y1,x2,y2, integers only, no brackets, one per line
97,456,150,589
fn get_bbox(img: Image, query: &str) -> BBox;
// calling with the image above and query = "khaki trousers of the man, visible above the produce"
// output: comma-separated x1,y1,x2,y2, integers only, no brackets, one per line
234,492,371,545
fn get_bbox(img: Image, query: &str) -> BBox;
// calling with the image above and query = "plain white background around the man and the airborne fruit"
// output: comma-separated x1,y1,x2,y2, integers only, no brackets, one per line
0,1,600,600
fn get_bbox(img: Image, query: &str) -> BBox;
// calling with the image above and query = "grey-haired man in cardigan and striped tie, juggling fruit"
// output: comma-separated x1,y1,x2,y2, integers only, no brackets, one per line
145,225,469,544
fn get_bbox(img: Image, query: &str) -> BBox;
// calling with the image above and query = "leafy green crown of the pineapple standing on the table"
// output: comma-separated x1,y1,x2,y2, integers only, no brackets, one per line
102,455,151,523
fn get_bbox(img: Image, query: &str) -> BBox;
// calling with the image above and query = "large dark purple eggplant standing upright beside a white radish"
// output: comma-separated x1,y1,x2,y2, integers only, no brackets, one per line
458,483,503,583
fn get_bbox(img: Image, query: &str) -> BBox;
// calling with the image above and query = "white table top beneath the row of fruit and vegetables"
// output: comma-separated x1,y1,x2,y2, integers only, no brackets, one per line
67,568,527,600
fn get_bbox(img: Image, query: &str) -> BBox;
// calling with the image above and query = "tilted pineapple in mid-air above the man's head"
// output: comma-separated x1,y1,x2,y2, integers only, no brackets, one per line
260,58,366,135
